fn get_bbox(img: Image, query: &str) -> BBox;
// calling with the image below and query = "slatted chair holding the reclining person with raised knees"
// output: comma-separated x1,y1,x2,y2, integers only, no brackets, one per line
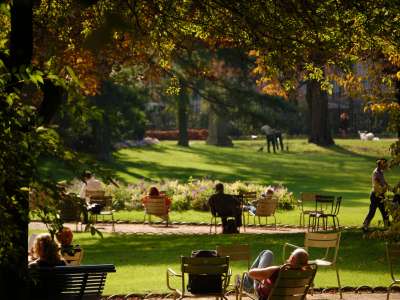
239,264,317,300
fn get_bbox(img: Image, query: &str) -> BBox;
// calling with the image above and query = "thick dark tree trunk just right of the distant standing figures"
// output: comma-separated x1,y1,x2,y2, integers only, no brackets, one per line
306,80,334,146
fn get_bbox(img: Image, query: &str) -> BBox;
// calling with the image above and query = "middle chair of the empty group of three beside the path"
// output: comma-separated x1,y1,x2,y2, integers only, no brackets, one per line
308,195,341,231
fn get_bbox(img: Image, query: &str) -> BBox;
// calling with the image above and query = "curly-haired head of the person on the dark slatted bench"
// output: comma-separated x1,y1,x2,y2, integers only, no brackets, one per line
33,233,61,264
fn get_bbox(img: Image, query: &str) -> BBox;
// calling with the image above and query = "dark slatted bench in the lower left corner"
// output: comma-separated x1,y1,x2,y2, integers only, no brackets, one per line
29,264,115,300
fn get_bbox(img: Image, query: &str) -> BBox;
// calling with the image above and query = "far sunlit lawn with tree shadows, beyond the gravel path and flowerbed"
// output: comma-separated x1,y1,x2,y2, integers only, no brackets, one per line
38,139,400,226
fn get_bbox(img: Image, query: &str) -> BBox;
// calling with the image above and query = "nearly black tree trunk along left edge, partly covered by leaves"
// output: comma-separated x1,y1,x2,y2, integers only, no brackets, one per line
0,0,33,299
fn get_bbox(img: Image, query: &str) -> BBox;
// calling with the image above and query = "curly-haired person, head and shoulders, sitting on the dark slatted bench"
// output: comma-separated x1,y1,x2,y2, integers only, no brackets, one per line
28,233,65,268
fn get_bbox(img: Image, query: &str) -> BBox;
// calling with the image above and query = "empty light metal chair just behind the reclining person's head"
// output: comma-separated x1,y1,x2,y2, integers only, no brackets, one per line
283,231,342,299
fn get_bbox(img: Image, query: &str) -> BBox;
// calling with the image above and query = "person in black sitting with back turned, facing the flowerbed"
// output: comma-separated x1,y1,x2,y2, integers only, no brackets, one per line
208,183,242,227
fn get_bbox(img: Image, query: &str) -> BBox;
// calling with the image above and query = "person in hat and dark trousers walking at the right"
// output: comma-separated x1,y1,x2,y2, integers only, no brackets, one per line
363,158,389,232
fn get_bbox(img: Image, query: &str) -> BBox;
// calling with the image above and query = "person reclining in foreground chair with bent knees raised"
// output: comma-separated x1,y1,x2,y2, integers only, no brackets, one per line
241,248,308,299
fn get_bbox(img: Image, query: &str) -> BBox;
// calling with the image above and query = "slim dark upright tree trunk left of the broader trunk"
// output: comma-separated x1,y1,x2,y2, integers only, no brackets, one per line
177,86,189,147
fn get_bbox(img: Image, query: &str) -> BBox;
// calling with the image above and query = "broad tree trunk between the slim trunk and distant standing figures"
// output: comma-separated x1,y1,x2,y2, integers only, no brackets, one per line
206,106,233,147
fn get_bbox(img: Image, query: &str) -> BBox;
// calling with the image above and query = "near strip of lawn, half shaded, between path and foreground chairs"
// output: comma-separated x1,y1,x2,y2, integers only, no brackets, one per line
30,231,390,295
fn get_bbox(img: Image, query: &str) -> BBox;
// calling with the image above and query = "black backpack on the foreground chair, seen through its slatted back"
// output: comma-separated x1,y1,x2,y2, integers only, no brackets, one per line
187,250,222,294
